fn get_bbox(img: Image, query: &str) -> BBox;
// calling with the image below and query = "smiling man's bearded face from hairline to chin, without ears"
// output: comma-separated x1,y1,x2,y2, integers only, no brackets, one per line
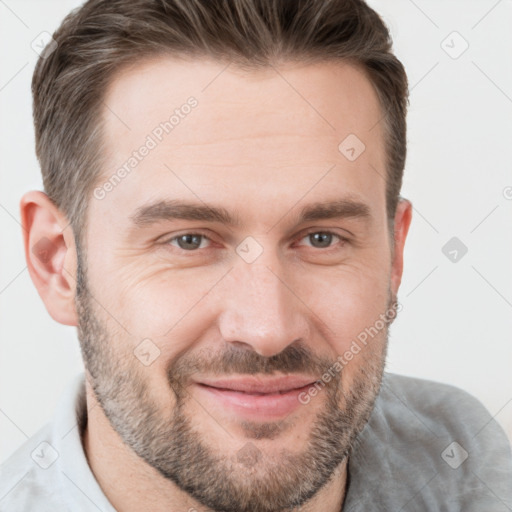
77,58,399,512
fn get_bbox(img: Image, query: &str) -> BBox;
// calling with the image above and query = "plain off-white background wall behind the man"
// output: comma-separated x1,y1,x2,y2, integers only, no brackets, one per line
0,0,512,461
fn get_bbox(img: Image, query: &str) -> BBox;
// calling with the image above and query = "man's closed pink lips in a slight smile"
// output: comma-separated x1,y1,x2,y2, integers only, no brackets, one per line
194,376,317,421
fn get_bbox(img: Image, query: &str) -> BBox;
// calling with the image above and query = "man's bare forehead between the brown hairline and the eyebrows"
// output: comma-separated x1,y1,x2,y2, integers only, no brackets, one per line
95,56,385,226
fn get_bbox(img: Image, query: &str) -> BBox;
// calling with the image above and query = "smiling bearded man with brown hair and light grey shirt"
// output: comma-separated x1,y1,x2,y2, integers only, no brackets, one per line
0,0,512,512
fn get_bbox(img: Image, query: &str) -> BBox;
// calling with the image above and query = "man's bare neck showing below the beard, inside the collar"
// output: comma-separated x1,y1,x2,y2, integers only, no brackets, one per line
83,383,347,512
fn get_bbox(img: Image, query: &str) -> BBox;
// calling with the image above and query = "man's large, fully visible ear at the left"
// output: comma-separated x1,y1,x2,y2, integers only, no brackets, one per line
20,191,78,326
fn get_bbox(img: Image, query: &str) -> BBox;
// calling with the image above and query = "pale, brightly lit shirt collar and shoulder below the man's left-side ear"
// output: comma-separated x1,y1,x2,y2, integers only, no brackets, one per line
0,373,114,512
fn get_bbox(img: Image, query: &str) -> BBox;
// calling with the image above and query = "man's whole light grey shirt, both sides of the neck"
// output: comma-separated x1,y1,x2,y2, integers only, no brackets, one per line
0,373,512,512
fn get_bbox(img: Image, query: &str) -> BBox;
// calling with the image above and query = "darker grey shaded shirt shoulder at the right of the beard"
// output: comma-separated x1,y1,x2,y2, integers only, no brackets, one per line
344,373,512,512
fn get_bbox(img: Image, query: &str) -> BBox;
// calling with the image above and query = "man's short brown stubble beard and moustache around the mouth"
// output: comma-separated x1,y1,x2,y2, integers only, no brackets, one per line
76,252,393,512
